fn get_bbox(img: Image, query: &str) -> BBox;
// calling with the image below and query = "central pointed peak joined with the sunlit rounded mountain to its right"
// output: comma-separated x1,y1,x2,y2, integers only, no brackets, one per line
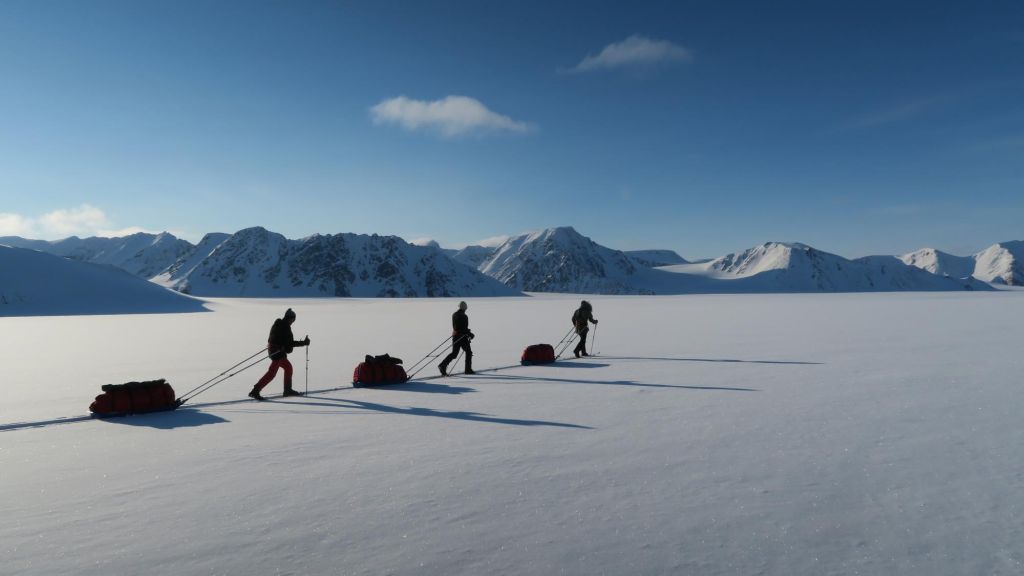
479,228,991,294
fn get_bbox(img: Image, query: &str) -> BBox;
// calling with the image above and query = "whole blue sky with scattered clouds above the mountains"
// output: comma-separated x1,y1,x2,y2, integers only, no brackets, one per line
0,0,1024,257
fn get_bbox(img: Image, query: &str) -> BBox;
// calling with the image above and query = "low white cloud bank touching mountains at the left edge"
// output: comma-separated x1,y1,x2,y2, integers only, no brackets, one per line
0,204,153,240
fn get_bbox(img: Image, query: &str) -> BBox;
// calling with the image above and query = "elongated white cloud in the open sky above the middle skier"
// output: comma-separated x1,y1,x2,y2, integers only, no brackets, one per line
370,96,534,137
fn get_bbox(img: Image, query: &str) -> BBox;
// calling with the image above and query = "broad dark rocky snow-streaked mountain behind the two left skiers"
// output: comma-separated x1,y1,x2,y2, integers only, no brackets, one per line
155,228,518,297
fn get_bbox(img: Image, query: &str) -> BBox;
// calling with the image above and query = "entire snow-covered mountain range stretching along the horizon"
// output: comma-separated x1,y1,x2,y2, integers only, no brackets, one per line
0,227,1011,297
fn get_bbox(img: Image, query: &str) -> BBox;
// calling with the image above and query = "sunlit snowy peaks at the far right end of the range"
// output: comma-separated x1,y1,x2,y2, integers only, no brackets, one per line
900,241,1024,286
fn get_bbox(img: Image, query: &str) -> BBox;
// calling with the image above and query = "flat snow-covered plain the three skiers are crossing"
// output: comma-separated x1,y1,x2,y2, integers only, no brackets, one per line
0,291,1024,576
